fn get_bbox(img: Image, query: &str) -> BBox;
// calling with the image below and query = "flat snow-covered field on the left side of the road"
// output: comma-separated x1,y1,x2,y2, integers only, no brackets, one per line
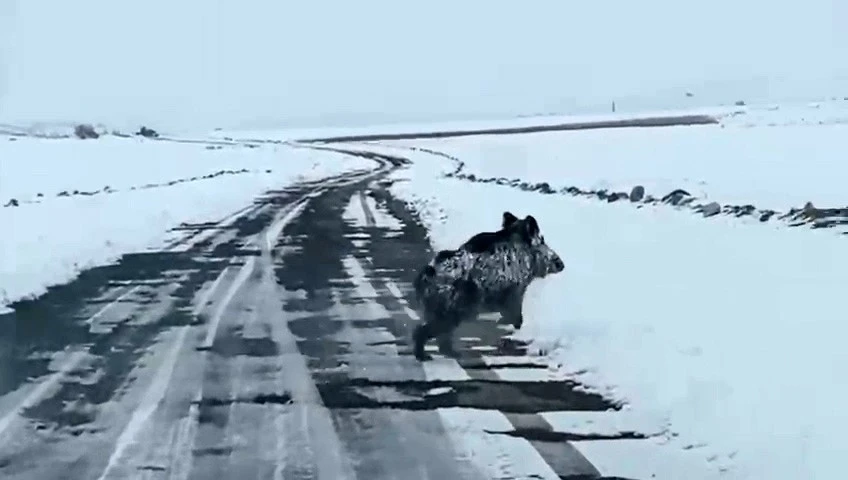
0,137,373,308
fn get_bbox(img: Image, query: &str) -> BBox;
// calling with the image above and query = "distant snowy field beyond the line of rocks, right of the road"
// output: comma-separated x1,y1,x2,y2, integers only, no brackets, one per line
390,102,848,212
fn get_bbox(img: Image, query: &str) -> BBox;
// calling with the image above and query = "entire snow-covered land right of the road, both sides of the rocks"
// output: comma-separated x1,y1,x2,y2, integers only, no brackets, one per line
376,111,848,480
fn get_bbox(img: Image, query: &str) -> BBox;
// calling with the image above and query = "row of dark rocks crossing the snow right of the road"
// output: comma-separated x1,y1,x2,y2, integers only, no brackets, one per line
444,171,848,234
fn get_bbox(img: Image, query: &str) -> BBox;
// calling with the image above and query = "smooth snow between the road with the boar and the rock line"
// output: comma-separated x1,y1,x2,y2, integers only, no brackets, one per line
392,143,848,480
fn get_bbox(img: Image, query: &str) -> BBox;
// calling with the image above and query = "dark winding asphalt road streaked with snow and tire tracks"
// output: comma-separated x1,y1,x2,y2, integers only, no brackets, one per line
0,148,636,480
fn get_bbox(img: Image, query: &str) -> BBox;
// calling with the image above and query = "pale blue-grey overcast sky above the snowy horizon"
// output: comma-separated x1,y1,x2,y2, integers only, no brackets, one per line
0,0,848,128
